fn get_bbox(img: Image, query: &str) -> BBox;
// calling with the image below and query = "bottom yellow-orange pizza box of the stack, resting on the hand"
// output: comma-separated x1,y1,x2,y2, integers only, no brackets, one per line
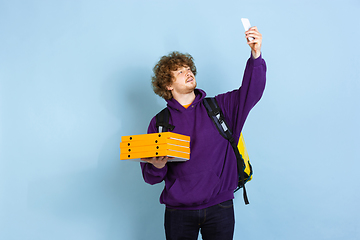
120,149,190,161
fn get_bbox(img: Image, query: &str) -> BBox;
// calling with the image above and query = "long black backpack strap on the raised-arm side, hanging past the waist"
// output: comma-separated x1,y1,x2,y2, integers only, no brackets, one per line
203,98,249,204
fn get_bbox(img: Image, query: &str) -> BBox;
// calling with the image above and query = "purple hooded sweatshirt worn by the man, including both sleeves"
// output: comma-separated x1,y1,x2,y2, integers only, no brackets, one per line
141,56,266,210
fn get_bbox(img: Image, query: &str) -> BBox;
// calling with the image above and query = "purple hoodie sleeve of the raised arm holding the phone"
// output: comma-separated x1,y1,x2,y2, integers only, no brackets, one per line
216,53,266,139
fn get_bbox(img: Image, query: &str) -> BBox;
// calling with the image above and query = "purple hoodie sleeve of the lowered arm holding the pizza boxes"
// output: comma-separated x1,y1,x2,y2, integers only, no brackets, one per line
140,117,167,185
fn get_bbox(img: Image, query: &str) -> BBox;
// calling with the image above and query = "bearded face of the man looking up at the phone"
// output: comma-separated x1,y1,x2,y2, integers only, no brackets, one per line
168,66,196,95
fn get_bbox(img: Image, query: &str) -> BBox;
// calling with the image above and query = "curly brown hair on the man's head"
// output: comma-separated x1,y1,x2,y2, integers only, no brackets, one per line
151,51,196,100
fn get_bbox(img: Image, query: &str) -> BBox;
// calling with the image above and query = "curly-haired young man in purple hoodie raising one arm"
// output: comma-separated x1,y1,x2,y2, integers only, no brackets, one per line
141,27,266,240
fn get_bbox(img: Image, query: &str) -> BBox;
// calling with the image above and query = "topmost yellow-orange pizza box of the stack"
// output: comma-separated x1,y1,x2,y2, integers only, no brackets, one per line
121,132,190,142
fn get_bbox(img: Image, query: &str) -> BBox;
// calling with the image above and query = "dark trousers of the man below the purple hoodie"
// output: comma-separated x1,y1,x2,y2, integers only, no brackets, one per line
165,200,235,240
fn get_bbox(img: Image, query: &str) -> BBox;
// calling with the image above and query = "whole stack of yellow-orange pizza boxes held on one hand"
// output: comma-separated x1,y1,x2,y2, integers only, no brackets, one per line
120,132,190,162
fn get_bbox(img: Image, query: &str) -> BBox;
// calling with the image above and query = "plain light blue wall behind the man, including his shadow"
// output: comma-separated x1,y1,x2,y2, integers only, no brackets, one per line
0,0,360,240
